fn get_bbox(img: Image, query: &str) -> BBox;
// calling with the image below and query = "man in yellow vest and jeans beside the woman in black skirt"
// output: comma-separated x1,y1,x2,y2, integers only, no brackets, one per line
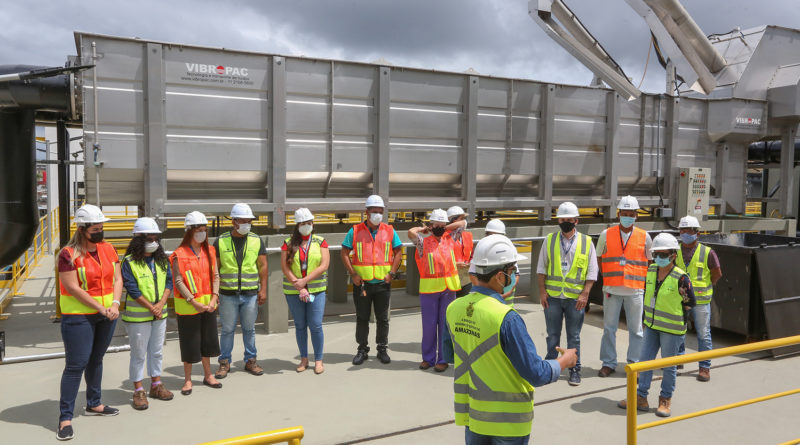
214,203,268,379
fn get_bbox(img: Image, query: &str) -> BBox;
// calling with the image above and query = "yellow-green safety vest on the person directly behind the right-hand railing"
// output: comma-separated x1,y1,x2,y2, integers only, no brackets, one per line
642,264,686,335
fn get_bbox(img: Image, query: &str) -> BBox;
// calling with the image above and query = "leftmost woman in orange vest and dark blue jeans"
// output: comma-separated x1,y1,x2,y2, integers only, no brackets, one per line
56,204,122,440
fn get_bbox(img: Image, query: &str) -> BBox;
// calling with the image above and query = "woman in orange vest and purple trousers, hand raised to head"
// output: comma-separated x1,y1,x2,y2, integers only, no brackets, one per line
408,209,461,372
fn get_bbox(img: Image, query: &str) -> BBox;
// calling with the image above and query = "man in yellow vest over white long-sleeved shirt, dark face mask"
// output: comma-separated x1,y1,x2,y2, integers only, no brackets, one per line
536,202,597,386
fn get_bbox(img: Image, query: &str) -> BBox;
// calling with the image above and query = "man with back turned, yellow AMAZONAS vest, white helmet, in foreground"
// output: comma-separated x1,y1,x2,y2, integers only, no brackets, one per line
445,235,577,444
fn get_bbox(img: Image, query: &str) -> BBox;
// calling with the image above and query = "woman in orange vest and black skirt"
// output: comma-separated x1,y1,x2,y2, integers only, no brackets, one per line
170,211,222,396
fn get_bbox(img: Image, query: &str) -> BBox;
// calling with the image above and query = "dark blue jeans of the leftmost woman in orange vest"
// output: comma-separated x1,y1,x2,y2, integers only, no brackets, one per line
58,314,117,422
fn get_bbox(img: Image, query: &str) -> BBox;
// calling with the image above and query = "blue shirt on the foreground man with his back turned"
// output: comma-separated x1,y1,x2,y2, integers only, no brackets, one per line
443,286,561,386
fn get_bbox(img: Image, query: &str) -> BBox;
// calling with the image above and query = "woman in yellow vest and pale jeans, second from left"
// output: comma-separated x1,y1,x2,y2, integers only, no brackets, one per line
122,218,173,410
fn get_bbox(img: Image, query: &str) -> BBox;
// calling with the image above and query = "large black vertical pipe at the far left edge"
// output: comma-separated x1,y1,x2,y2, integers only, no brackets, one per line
0,108,39,267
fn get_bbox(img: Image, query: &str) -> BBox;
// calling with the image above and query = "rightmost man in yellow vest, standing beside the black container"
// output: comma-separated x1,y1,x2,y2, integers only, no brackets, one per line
675,216,722,382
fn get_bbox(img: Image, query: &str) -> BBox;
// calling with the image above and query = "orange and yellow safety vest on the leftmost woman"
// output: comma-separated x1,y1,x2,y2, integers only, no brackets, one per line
59,242,119,315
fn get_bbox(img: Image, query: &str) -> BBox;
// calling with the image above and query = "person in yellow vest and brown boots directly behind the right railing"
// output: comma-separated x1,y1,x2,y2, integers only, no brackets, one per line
618,233,695,417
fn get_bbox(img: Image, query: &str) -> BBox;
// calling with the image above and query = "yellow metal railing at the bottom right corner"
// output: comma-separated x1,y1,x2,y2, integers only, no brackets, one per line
625,335,800,445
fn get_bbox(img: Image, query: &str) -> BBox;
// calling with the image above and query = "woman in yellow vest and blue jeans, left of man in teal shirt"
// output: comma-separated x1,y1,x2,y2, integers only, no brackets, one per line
281,208,330,374
